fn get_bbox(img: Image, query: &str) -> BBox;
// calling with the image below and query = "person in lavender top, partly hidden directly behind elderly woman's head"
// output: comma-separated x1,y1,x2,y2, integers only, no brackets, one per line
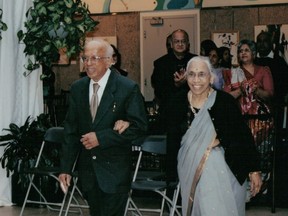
209,48,224,90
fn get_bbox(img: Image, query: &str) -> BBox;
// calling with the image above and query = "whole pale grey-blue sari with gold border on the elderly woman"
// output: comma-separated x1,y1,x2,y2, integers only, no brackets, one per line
178,91,246,216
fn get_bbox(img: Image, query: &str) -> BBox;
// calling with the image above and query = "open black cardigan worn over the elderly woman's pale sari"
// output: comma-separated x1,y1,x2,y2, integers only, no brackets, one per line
167,88,260,184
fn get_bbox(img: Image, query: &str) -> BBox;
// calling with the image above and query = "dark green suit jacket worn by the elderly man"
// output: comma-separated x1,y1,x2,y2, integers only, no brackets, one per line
61,69,147,193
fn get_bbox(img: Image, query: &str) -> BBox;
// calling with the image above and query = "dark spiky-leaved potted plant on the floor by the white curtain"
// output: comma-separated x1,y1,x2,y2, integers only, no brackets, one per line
0,114,55,203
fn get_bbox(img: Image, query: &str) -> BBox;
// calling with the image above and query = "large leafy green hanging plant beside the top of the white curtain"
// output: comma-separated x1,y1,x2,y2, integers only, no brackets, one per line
17,0,98,76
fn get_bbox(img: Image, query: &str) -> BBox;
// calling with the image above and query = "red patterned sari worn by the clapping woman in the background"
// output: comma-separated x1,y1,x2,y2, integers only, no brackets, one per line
223,65,274,198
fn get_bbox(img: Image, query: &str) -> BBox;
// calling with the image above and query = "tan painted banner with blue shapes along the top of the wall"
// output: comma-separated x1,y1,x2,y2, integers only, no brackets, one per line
82,0,205,14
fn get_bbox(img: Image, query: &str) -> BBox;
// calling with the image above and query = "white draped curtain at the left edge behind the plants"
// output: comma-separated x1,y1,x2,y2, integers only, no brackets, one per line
0,0,43,206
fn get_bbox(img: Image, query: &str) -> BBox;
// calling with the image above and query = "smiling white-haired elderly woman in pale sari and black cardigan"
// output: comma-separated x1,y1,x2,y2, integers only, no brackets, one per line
167,56,262,216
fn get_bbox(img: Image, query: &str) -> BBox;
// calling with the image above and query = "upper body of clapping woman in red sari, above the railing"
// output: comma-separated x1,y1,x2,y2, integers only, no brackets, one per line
223,39,274,118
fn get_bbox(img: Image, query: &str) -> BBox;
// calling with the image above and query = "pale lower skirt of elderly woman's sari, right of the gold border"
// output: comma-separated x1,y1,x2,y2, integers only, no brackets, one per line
191,147,247,216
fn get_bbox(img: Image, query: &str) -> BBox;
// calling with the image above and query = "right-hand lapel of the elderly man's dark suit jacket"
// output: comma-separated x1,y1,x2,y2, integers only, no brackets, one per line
93,70,117,125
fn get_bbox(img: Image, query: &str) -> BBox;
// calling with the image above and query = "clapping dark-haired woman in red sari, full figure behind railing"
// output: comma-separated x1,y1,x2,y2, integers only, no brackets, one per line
223,39,274,203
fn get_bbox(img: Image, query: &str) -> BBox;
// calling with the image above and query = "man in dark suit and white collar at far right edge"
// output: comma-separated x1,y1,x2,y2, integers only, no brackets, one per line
255,32,288,206
